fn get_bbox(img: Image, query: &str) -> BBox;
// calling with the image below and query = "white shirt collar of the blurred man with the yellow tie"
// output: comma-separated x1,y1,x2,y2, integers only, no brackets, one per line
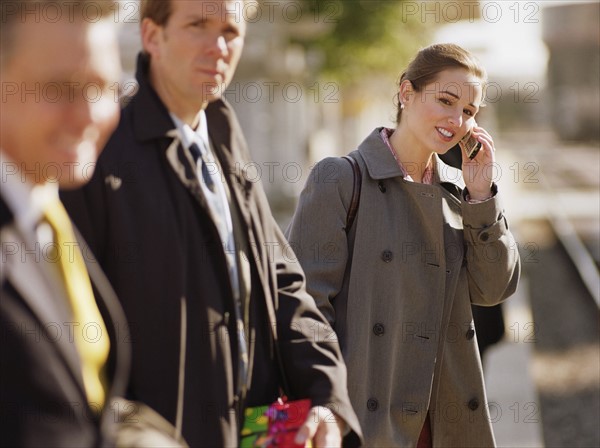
0,150,58,231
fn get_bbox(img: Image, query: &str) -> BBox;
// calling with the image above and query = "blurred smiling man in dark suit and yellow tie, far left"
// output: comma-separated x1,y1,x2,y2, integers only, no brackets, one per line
0,0,128,447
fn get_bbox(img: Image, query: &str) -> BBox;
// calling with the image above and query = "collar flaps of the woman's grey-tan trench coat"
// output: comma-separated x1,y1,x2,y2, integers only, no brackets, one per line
358,128,464,188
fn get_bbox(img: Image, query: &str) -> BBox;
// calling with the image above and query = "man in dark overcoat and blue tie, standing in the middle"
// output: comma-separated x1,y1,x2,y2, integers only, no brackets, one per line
63,0,360,447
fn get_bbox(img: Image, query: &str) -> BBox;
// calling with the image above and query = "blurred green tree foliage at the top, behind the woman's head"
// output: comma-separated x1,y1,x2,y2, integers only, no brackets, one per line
295,0,436,87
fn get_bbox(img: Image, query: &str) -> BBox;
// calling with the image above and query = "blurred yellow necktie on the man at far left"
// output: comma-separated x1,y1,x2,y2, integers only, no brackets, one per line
44,199,110,408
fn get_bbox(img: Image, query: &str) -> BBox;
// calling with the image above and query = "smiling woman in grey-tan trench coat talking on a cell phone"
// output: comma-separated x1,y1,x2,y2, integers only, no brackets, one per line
287,44,520,447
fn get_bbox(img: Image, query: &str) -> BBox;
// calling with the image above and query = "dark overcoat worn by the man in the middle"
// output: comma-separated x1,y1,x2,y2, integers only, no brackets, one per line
63,57,360,447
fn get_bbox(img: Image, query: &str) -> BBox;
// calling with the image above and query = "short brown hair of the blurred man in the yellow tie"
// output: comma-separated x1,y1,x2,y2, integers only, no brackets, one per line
0,0,118,64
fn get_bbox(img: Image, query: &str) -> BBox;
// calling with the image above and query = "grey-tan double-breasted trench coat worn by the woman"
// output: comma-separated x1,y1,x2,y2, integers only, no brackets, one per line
287,129,520,447
